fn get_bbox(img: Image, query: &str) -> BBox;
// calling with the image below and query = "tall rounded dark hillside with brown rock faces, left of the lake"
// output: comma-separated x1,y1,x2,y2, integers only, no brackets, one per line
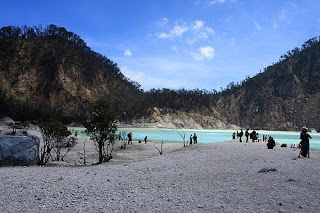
0,25,141,121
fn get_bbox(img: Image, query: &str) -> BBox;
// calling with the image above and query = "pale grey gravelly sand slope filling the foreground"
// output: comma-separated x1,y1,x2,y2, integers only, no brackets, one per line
0,138,320,213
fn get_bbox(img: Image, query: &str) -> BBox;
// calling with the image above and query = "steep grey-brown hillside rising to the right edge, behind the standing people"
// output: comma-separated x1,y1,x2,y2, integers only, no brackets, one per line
215,37,320,130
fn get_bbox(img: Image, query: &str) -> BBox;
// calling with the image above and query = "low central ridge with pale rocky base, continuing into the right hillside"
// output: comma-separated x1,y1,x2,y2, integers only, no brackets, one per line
132,37,320,130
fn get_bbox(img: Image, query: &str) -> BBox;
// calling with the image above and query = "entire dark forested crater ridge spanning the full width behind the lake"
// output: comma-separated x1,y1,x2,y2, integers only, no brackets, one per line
0,25,320,130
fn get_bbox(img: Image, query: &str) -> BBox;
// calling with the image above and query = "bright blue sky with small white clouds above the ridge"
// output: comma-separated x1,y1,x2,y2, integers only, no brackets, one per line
0,0,320,90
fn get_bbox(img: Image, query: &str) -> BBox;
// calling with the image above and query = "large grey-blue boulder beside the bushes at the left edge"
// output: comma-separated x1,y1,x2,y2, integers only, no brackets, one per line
0,136,40,166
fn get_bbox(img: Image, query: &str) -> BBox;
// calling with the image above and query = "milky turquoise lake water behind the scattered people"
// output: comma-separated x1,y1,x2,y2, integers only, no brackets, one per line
70,127,320,150
